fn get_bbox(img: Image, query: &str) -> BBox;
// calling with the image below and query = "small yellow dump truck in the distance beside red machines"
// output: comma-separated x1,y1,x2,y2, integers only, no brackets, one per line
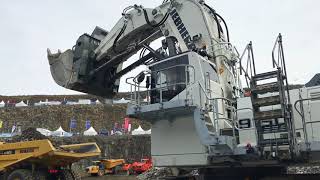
86,159,125,176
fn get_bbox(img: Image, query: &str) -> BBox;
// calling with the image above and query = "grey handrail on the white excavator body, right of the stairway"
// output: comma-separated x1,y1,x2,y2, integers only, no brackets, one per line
294,97,320,150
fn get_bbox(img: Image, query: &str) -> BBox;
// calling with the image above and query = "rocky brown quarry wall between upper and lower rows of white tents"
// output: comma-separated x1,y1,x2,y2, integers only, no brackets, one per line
0,103,150,132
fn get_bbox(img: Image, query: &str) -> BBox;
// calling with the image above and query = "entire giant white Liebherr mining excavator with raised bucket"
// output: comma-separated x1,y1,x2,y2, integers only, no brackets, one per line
48,0,320,179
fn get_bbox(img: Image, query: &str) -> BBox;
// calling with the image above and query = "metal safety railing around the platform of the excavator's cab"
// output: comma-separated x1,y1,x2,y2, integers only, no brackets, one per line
126,64,195,106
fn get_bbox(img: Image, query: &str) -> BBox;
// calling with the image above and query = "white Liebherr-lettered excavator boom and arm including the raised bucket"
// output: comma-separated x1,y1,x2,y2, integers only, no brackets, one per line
48,0,231,98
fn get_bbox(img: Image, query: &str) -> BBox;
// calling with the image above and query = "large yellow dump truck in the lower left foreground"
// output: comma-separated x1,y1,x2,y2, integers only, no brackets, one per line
0,140,101,180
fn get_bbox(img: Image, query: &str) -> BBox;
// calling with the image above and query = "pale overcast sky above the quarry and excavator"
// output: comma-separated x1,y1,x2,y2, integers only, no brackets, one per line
0,0,320,95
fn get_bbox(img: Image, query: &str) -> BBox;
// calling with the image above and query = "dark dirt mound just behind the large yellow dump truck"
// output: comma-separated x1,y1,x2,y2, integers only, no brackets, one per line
12,128,48,142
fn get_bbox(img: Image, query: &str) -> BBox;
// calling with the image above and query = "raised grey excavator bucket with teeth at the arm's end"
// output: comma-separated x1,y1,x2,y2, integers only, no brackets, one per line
47,34,122,98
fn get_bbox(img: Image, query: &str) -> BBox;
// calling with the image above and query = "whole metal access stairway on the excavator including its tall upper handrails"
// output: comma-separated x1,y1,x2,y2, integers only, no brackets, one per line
241,34,295,159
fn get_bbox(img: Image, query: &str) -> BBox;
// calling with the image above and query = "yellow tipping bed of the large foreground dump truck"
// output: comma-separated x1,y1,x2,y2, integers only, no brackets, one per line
0,140,101,171
